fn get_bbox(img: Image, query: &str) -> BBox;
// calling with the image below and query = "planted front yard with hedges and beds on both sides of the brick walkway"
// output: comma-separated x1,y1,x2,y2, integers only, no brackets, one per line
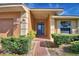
0,34,79,56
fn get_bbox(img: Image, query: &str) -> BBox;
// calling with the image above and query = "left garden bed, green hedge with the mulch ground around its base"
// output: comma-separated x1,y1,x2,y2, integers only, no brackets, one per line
0,36,32,56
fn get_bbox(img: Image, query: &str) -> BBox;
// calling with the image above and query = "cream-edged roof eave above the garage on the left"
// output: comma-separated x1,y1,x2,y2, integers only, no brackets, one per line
0,4,28,12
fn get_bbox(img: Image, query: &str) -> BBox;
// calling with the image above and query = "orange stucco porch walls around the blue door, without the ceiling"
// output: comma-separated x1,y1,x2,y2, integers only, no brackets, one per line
29,14,50,38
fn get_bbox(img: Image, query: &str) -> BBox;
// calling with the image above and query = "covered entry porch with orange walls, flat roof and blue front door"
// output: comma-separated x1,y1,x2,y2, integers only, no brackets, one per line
31,9,62,38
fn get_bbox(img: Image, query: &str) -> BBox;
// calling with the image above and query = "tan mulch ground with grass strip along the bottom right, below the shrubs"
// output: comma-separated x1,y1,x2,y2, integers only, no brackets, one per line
48,46,79,56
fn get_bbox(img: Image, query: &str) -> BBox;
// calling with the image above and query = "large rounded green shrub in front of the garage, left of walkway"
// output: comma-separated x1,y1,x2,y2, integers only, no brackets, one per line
1,36,32,54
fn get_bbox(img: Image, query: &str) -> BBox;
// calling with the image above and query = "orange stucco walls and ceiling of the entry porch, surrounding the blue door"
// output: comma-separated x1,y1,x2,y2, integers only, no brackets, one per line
29,11,58,38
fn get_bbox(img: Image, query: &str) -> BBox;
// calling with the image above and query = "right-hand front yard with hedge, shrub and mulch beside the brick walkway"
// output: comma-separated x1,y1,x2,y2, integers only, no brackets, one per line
48,34,79,56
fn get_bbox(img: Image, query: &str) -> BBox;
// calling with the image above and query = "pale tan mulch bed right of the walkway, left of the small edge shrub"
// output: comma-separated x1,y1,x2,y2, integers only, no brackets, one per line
48,44,70,56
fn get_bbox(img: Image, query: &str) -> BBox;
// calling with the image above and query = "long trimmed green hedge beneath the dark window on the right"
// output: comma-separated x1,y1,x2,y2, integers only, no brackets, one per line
52,34,79,46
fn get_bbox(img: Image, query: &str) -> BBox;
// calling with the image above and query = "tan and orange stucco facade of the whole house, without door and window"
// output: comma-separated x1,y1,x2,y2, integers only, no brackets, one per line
0,4,79,38
